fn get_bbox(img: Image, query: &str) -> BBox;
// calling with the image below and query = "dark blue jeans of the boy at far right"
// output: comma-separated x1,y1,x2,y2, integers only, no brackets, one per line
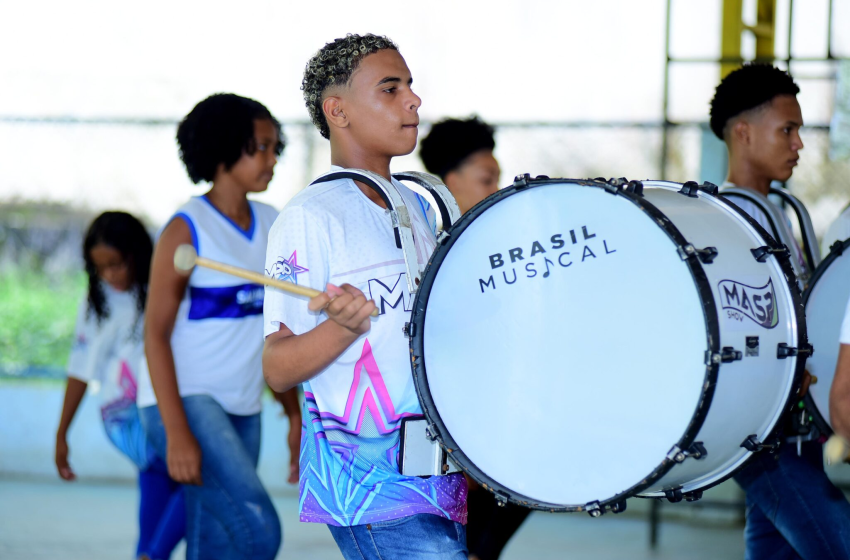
735,441,850,560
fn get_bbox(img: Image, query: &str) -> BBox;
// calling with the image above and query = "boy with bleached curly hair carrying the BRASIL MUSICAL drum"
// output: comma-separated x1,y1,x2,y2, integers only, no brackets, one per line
263,34,467,560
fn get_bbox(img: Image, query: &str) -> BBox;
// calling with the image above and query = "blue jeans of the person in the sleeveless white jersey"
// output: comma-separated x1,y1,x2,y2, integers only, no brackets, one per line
140,395,282,560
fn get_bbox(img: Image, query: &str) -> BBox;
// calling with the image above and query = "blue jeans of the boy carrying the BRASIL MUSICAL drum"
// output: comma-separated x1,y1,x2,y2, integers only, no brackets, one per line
328,513,468,560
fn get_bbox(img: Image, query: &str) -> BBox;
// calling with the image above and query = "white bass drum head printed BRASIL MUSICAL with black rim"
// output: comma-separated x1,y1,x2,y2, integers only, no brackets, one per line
412,180,716,510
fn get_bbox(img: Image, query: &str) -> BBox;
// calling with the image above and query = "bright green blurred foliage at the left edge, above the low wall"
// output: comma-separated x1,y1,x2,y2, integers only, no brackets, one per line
0,269,86,374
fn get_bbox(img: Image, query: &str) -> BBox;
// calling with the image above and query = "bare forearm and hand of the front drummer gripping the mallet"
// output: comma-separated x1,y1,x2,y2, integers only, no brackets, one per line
263,284,375,392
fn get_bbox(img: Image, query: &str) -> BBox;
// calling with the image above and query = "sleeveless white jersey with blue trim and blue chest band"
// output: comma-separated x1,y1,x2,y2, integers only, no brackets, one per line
138,196,278,415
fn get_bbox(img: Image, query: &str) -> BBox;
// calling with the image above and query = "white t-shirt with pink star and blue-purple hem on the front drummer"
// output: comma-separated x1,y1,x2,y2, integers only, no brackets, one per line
264,168,466,526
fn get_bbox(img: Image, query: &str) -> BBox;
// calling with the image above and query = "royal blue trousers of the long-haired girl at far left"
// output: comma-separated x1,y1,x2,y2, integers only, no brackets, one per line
136,456,186,560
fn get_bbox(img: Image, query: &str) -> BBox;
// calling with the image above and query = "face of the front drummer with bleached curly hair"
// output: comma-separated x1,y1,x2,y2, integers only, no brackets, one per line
338,49,422,157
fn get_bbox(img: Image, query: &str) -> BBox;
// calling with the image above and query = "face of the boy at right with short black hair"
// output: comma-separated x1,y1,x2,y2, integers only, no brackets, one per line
746,95,803,181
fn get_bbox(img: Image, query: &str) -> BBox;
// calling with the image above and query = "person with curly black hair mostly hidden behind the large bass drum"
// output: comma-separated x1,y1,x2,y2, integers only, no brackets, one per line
419,117,531,560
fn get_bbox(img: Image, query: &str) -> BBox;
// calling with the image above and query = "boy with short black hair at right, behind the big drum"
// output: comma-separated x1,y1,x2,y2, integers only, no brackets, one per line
711,64,850,560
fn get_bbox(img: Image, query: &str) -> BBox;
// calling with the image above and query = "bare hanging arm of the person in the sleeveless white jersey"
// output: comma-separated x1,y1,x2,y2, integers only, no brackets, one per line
145,218,203,484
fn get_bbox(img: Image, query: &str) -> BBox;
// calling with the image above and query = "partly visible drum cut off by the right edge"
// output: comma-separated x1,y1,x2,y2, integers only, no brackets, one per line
803,239,850,435
